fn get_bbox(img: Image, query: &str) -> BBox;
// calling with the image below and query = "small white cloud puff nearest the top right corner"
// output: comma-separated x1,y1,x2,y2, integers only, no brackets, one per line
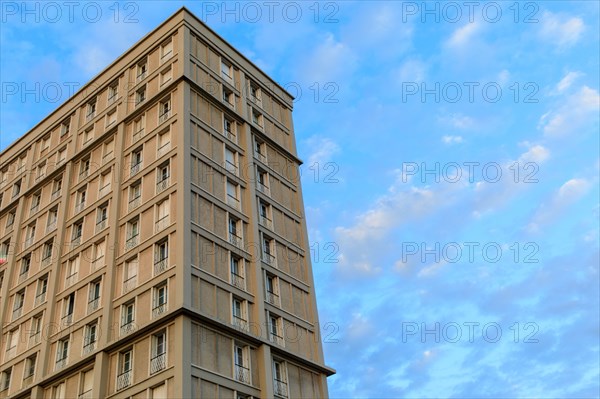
540,11,585,48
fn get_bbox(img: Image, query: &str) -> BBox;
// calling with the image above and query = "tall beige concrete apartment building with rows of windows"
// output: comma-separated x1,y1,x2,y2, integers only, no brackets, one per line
0,8,333,399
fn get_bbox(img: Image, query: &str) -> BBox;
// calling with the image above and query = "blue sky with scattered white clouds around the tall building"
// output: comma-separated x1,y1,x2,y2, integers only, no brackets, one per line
0,1,600,399
